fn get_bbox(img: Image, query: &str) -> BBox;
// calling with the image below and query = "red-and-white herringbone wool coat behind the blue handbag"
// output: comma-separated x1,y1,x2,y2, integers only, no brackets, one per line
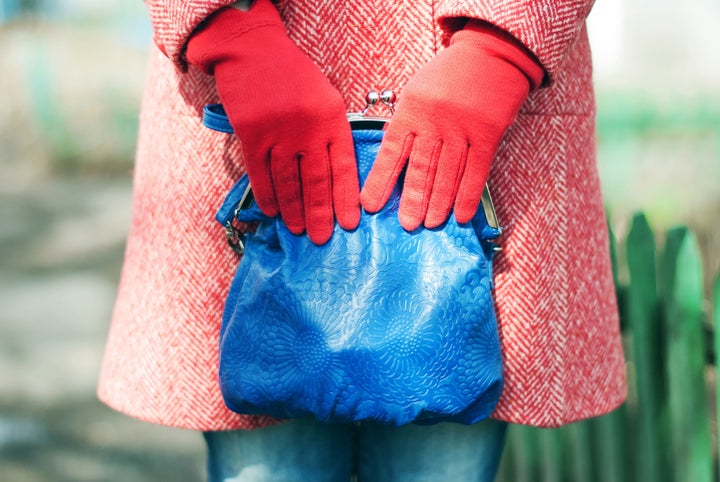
99,0,626,430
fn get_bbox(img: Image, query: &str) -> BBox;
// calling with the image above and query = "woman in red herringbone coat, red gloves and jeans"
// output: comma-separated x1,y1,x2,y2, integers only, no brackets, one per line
99,0,625,480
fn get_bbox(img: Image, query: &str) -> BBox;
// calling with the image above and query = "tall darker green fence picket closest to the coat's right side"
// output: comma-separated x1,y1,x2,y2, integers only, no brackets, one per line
626,214,668,482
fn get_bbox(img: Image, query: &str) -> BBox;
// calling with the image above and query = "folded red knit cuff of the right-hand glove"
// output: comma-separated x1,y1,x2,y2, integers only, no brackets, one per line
450,19,545,92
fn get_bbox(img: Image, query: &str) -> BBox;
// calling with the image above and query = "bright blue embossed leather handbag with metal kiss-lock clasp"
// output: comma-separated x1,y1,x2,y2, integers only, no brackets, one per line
204,106,503,425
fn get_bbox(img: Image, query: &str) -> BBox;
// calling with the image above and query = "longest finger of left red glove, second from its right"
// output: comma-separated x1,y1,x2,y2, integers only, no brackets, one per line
300,146,335,244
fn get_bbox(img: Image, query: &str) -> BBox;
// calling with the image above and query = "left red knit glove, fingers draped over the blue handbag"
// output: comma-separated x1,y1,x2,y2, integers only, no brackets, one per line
187,0,360,244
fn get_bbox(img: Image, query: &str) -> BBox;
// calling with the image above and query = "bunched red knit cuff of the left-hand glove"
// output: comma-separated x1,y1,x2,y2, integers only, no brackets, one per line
186,0,287,75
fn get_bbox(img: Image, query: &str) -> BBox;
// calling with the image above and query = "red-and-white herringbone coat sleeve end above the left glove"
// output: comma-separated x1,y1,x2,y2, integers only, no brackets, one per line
145,0,282,71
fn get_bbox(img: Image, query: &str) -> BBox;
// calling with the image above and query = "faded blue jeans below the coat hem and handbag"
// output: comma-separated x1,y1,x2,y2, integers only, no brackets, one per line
205,419,507,482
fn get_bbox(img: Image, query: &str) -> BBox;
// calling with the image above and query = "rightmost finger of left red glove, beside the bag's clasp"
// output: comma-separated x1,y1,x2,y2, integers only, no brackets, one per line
328,132,360,229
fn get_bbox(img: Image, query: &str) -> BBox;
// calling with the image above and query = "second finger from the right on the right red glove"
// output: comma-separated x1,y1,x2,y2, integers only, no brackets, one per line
425,140,468,228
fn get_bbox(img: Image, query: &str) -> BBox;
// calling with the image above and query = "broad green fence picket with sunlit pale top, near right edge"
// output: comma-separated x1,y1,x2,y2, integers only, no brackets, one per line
663,228,713,482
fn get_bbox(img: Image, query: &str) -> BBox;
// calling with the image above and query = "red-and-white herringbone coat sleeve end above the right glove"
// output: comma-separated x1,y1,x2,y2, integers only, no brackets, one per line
436,0,594,85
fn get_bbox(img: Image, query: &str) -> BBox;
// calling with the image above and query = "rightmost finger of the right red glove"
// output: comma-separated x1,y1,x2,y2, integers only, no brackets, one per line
455,145,494,224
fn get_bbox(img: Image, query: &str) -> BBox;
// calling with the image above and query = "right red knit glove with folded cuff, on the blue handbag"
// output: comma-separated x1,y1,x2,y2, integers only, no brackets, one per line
360,21,543,231
